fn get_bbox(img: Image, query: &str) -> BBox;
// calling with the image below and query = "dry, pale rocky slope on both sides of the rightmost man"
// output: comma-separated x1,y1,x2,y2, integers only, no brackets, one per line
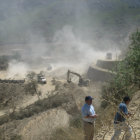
96,91,140,140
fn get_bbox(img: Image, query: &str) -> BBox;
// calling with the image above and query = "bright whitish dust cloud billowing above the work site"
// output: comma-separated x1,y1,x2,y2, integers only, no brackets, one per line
20,25,120,71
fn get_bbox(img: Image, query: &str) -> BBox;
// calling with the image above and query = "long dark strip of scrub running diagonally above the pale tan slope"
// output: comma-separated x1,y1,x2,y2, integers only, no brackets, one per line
0,94,77,125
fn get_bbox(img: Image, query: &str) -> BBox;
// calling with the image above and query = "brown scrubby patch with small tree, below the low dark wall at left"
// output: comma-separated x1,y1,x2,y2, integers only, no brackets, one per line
0,72,41,109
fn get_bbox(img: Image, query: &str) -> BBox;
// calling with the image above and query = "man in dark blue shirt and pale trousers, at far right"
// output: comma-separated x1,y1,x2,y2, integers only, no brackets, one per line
111,96,132,140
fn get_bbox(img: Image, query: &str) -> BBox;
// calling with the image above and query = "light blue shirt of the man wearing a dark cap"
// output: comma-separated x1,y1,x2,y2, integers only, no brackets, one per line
82,104,95,123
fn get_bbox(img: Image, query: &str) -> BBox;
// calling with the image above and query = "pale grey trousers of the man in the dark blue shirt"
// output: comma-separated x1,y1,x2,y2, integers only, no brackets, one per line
111,122,132,140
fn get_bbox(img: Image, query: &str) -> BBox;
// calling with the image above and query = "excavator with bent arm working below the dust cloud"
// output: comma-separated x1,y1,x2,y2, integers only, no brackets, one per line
67,70,89,86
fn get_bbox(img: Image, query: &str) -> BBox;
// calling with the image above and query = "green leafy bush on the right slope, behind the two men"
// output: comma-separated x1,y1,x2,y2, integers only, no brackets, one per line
102,31,140,106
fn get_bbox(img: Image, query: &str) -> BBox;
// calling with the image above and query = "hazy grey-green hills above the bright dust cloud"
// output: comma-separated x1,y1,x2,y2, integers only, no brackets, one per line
0,0,140,50
